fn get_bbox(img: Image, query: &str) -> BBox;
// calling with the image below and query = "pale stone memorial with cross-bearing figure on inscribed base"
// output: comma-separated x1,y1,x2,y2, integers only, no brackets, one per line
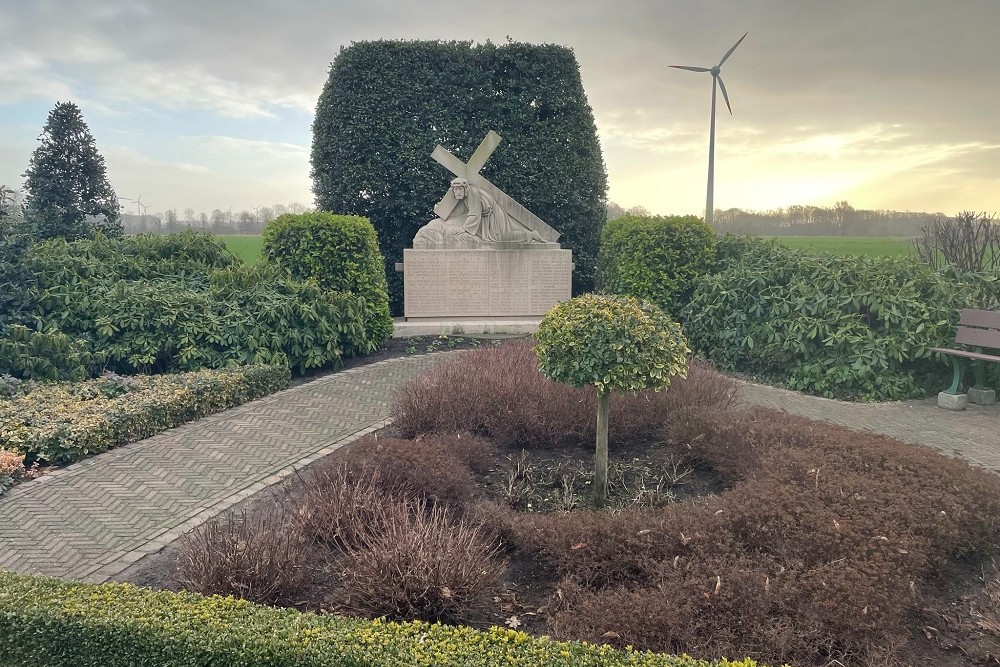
397,130,573,333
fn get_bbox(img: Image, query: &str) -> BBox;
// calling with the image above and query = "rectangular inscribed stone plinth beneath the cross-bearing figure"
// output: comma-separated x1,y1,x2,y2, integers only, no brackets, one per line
403,244,573,321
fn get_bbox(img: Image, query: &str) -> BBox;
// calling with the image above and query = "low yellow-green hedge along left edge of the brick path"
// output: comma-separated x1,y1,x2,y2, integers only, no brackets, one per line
0,366,291,465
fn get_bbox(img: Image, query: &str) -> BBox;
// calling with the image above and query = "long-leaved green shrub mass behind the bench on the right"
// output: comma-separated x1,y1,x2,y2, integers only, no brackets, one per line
680,238,1000,400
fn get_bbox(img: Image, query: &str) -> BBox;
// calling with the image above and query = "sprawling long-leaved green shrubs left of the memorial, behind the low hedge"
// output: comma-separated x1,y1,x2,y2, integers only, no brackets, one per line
10,232,369,377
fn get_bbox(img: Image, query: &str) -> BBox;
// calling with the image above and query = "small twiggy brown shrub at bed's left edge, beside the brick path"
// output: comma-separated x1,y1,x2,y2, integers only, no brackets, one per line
295,458,406,549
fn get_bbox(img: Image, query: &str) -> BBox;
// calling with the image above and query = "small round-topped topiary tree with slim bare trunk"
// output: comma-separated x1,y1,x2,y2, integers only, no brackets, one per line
535,294,691,505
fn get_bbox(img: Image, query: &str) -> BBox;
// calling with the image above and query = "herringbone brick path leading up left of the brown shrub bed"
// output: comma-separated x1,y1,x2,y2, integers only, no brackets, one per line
0,353,458,582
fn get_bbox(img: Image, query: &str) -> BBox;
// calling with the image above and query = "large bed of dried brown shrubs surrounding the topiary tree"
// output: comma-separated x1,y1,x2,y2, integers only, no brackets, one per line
158,344,1000,665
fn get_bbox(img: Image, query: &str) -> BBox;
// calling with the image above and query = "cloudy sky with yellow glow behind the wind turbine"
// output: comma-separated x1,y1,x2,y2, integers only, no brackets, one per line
0,0,1000,215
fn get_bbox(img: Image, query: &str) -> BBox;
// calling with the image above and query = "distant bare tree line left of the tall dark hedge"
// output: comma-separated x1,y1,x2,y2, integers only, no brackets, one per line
121,202,311,234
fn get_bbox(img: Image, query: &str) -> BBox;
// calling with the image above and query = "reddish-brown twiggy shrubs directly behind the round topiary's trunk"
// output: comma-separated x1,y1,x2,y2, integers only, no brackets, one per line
393,341,735,449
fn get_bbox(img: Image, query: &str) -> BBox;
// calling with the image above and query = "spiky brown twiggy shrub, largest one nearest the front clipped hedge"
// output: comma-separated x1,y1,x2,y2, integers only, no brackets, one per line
342,500,507,621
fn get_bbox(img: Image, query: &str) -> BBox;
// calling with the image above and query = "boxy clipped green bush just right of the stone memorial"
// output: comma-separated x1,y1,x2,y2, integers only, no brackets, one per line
597,215,715,313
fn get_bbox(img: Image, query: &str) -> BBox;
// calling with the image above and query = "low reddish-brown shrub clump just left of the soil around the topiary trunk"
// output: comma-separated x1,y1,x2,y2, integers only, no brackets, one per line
349,434,495,506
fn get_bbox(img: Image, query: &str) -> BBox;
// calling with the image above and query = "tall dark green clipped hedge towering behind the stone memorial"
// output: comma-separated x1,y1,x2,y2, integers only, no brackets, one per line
312,39,607,312
